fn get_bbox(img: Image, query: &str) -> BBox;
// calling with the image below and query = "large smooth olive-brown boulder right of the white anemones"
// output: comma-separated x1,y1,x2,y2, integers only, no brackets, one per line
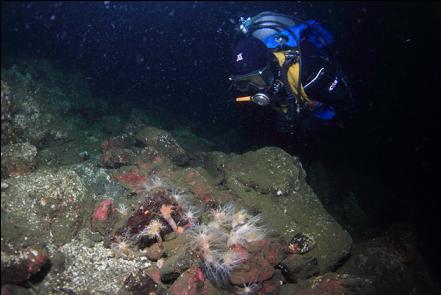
211,147,352,273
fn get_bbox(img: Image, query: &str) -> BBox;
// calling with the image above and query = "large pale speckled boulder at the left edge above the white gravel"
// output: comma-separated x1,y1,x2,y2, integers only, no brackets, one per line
1,169,93,246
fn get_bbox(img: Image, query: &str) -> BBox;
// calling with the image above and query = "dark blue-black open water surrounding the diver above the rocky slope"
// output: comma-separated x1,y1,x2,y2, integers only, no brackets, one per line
1,1,441,278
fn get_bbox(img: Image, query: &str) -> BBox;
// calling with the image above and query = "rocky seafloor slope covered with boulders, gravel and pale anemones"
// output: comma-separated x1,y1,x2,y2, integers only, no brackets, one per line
1,60,439,294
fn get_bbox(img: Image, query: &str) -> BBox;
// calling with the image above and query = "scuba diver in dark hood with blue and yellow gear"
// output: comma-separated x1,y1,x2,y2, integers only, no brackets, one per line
229,12,352,134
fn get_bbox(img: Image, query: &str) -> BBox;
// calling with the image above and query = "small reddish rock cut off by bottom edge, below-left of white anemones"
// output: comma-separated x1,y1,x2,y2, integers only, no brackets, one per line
168,267,205,295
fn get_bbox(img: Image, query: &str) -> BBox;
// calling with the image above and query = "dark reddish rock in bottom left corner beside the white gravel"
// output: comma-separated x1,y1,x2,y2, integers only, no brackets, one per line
1,246,48,285
